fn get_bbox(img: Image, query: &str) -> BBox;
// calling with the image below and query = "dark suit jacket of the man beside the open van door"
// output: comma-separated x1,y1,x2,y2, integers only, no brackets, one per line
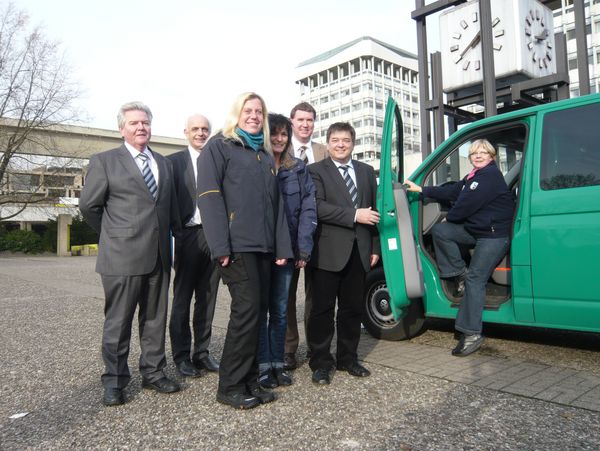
308,158,381,272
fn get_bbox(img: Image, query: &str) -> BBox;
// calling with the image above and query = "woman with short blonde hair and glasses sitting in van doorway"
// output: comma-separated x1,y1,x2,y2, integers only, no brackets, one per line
404,139,515,356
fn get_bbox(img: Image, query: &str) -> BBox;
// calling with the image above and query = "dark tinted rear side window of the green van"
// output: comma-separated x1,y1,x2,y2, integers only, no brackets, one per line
540,104,600,190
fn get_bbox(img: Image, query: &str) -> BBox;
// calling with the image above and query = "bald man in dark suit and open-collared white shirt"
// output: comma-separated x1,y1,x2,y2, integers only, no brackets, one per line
167,114,219,377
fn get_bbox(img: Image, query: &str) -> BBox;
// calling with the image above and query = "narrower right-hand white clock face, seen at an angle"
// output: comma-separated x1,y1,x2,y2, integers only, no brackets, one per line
523,7,553,72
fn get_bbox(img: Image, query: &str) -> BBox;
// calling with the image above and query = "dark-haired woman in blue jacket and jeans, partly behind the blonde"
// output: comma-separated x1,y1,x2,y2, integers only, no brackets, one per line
258,114,317,388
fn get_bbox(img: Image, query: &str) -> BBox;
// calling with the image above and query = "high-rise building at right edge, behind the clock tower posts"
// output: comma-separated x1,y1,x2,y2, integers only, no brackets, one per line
553,0,600,97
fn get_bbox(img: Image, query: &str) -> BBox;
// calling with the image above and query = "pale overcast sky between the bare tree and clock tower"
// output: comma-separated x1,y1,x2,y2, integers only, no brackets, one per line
17,0,440,137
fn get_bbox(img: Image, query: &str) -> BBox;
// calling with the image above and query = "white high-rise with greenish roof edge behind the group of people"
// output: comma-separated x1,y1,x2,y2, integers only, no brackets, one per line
296,36,421,170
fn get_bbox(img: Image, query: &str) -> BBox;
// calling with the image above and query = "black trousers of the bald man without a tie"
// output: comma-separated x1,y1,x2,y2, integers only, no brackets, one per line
169,226,219,363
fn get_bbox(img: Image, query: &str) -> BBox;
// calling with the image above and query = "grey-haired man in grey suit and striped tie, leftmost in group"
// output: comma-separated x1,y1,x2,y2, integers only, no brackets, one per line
79,102,180,406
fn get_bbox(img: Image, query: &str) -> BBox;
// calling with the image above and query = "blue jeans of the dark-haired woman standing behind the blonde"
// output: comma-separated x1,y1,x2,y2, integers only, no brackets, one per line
258,261,294,373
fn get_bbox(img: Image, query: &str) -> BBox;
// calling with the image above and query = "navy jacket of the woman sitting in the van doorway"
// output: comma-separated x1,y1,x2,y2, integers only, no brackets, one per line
422,161,515,238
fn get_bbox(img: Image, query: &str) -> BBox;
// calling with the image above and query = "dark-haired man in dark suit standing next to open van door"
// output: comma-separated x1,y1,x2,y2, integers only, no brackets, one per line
307,122,380,385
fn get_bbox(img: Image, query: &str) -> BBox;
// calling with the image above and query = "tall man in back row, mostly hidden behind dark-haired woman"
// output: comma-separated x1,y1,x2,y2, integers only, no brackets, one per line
283,102,328,370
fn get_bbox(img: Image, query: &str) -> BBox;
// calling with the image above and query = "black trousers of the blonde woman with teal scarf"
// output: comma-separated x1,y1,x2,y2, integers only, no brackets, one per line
218,252,273,394
